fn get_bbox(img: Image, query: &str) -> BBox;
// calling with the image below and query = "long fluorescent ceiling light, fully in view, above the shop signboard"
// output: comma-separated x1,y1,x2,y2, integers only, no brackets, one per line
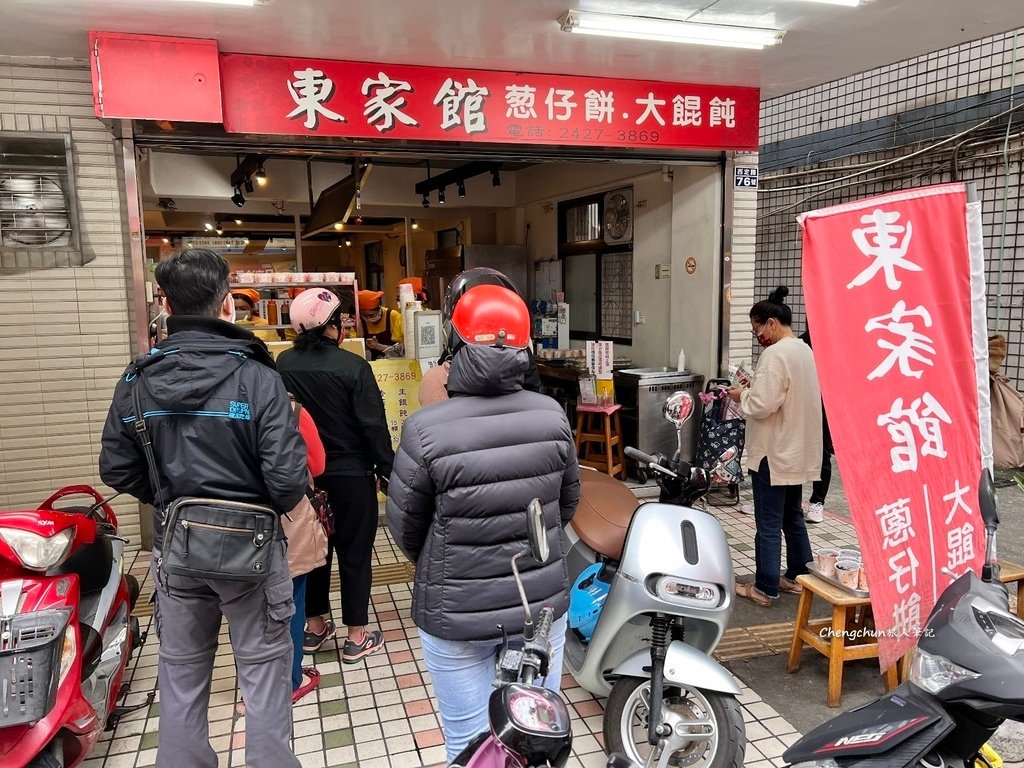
558,10,785,50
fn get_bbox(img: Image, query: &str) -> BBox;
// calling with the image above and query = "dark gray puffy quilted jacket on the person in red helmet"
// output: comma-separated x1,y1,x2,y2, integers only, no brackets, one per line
387,345,580,640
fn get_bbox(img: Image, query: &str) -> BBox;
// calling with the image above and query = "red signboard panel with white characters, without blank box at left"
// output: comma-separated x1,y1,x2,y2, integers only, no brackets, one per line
220,53,759,150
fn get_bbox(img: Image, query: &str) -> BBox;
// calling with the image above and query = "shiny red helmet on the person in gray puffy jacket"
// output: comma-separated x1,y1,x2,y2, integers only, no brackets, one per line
452,286,529,349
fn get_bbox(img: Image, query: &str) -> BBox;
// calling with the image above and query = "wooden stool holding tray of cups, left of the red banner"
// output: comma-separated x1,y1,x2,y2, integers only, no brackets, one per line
786,574,899,707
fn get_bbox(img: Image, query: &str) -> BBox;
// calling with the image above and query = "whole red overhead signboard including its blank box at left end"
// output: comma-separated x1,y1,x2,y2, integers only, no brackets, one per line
90,32,760,151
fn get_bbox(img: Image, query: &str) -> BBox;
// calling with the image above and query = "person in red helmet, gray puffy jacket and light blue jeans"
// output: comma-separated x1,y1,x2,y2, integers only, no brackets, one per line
387,285,580,763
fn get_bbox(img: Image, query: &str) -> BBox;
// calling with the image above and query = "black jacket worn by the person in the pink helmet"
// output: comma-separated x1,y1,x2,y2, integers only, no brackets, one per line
278,339,394,478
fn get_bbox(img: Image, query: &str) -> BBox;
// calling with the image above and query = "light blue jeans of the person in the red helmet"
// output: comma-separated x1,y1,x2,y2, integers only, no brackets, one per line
420,615,566,763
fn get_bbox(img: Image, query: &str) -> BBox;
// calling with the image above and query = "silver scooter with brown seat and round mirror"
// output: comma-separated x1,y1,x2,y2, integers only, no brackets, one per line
564,392,746,768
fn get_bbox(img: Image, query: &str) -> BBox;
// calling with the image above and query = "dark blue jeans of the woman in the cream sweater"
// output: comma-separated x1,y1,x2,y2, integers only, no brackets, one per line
751,459,814,597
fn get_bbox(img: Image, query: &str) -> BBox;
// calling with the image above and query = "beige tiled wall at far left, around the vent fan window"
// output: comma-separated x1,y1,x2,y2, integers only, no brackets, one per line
0,56,139,544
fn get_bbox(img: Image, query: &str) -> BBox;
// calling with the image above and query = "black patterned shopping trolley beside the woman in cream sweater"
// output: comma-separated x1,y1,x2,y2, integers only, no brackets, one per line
694,379,746,507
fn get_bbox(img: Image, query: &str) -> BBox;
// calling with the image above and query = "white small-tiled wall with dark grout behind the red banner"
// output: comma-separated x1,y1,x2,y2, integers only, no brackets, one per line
745,30,1024,389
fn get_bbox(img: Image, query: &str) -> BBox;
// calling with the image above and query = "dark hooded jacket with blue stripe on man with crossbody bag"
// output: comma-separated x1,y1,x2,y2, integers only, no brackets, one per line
99,316,308,546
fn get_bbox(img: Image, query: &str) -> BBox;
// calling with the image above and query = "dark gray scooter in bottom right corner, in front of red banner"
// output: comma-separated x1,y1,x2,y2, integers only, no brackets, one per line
782,469,1024,768
